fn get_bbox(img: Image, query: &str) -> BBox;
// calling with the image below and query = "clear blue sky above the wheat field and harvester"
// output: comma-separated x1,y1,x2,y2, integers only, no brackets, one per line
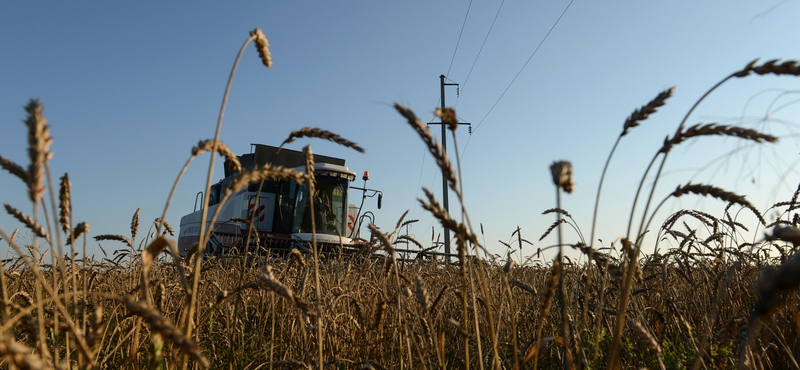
0,0,800,256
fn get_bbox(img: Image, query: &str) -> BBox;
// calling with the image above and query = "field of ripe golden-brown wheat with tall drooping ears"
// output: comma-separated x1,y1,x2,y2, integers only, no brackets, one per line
0,29,800,369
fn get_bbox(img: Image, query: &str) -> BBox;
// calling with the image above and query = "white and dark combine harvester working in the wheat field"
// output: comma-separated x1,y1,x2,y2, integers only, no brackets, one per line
178,144,383,256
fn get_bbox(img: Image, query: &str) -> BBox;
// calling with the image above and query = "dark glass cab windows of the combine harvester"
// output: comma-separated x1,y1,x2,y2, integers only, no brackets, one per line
292,176,349,236
